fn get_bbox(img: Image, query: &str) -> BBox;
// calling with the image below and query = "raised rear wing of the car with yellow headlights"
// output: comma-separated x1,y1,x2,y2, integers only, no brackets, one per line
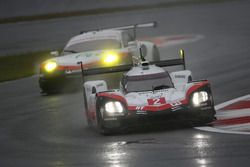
80,21,157,39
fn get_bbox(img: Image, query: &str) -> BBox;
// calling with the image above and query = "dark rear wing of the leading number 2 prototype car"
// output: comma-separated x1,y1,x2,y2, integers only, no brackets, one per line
77,50,186,78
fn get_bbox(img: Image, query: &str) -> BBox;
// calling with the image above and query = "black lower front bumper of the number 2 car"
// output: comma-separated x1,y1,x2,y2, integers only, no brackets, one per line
100,106,215,130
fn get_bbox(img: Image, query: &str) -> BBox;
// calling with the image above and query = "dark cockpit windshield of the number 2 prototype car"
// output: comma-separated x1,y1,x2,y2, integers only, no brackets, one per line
125,72,173,93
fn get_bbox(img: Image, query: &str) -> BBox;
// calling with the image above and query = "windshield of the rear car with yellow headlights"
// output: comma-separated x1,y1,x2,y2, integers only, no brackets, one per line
63,39,121,54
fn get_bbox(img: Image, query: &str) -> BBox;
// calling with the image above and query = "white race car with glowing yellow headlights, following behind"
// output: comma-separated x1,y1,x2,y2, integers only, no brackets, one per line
39,22,160,93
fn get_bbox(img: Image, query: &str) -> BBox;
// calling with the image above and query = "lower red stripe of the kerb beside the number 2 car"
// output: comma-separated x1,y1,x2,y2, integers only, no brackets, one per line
212,116,250,125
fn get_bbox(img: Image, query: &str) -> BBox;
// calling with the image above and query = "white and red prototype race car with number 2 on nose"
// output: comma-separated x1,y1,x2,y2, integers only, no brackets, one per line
82,50,215,134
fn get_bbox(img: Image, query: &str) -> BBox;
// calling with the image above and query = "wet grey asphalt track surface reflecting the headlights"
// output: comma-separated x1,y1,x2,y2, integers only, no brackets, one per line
0,1,250,167
